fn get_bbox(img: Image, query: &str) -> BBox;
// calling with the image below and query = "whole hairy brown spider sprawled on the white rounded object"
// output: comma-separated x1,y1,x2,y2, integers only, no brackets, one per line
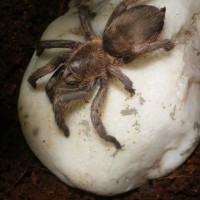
28,0,174,149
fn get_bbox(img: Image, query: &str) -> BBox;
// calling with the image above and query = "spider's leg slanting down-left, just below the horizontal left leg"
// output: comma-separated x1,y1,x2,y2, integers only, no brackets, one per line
28,53,70,88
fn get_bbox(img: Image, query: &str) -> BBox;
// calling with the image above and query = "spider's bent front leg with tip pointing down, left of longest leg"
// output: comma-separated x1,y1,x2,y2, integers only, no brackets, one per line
53,90,89,137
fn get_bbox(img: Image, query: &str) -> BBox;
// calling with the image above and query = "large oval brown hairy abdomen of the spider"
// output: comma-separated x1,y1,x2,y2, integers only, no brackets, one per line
103,5,166,58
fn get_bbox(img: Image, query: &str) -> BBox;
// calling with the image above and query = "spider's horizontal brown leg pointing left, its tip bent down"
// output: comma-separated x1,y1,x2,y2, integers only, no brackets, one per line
36,40,82,56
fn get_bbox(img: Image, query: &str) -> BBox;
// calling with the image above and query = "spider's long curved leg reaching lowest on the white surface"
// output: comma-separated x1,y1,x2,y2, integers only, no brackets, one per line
91,79,121,149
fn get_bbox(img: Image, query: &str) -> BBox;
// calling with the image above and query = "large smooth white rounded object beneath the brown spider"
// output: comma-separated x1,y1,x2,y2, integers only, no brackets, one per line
19,0,200,195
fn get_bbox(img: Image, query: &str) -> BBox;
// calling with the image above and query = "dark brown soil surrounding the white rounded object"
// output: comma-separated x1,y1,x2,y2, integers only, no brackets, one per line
0,0,200,200
